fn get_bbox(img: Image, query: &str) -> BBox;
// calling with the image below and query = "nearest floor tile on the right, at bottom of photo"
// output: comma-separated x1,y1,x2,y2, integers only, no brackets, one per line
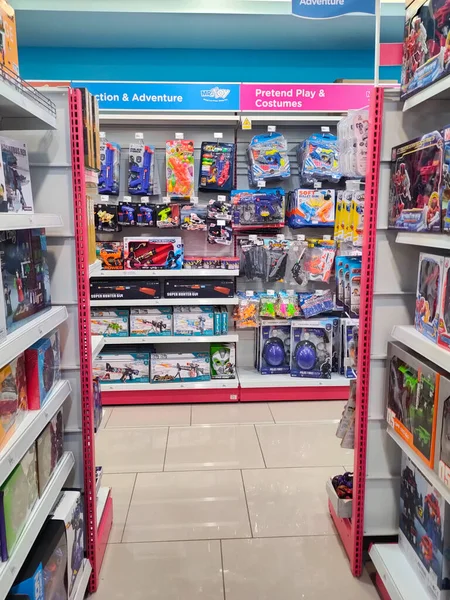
222,536,378,600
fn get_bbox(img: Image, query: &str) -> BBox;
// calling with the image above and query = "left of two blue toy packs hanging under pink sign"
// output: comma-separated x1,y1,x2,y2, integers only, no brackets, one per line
248,133,291,185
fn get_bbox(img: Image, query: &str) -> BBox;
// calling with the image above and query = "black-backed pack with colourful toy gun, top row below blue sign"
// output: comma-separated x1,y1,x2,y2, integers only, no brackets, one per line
198,142,235,192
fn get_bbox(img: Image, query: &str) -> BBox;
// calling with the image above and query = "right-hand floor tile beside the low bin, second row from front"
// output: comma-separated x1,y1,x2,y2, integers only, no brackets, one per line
243,467,341,537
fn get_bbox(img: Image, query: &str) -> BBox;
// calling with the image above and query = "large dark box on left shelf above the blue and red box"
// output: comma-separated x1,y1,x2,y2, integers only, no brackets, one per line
0,229,51,331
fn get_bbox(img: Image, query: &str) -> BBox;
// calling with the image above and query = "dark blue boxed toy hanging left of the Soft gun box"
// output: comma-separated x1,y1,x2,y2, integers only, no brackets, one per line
231,188,285,229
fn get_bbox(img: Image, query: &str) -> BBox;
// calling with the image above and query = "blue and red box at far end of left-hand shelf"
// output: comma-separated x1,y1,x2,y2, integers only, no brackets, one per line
25,331,61,410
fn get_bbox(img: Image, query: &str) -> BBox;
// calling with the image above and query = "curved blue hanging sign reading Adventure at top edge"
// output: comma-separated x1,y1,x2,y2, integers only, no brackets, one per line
292,0,378,19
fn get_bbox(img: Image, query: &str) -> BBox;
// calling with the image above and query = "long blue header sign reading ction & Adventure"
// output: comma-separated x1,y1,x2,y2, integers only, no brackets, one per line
72,81,240,111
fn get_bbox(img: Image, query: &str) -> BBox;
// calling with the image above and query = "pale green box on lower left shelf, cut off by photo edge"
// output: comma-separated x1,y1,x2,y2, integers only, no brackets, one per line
0,444,38,561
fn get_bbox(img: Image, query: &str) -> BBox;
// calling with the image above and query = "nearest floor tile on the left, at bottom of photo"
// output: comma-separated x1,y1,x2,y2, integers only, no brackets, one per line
91,541,223,600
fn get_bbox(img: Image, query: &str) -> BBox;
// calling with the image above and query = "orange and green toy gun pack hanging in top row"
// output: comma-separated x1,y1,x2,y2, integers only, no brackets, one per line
166,140,194,199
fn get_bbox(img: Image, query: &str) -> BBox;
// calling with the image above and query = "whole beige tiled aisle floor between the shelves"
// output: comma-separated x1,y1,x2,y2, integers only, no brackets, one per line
93,402,378,600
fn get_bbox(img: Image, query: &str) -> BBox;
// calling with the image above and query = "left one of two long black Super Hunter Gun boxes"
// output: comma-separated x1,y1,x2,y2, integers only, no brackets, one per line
90,278,161,300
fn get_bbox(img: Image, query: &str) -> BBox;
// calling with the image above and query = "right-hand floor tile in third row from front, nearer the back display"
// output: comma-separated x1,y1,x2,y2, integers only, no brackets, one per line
256,423,353,468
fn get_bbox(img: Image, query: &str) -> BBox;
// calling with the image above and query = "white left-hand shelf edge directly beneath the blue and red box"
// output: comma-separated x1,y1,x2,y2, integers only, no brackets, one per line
0,381,71,484
